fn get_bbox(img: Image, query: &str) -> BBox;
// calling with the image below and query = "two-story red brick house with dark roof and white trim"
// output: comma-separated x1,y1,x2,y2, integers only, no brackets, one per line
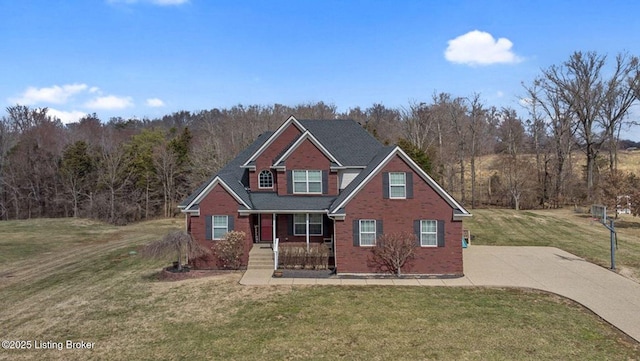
179,117,471,275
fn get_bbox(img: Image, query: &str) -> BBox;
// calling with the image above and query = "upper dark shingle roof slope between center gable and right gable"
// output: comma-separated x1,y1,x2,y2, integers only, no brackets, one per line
300,119,384,167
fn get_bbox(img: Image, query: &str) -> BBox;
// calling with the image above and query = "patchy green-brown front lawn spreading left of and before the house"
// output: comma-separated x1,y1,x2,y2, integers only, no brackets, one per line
0,215,640,360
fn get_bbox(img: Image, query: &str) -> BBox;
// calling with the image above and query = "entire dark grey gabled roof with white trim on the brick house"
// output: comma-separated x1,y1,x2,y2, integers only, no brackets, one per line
178,116,471,218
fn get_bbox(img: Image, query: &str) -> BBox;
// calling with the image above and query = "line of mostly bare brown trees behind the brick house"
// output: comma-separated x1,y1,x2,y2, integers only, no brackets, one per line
0,52,640,224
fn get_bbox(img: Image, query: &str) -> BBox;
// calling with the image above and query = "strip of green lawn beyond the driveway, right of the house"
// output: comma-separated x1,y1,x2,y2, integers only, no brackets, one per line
464,209,640,281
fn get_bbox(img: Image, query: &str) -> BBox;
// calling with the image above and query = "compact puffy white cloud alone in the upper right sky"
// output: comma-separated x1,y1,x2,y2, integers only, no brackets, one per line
444,30,522,66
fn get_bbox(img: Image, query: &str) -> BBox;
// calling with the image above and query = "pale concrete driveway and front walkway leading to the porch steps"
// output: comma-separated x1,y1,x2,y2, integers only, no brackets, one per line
240,246,640,342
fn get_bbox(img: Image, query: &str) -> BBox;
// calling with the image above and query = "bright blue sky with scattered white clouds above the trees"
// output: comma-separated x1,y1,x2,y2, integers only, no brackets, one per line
0,0,640,140
